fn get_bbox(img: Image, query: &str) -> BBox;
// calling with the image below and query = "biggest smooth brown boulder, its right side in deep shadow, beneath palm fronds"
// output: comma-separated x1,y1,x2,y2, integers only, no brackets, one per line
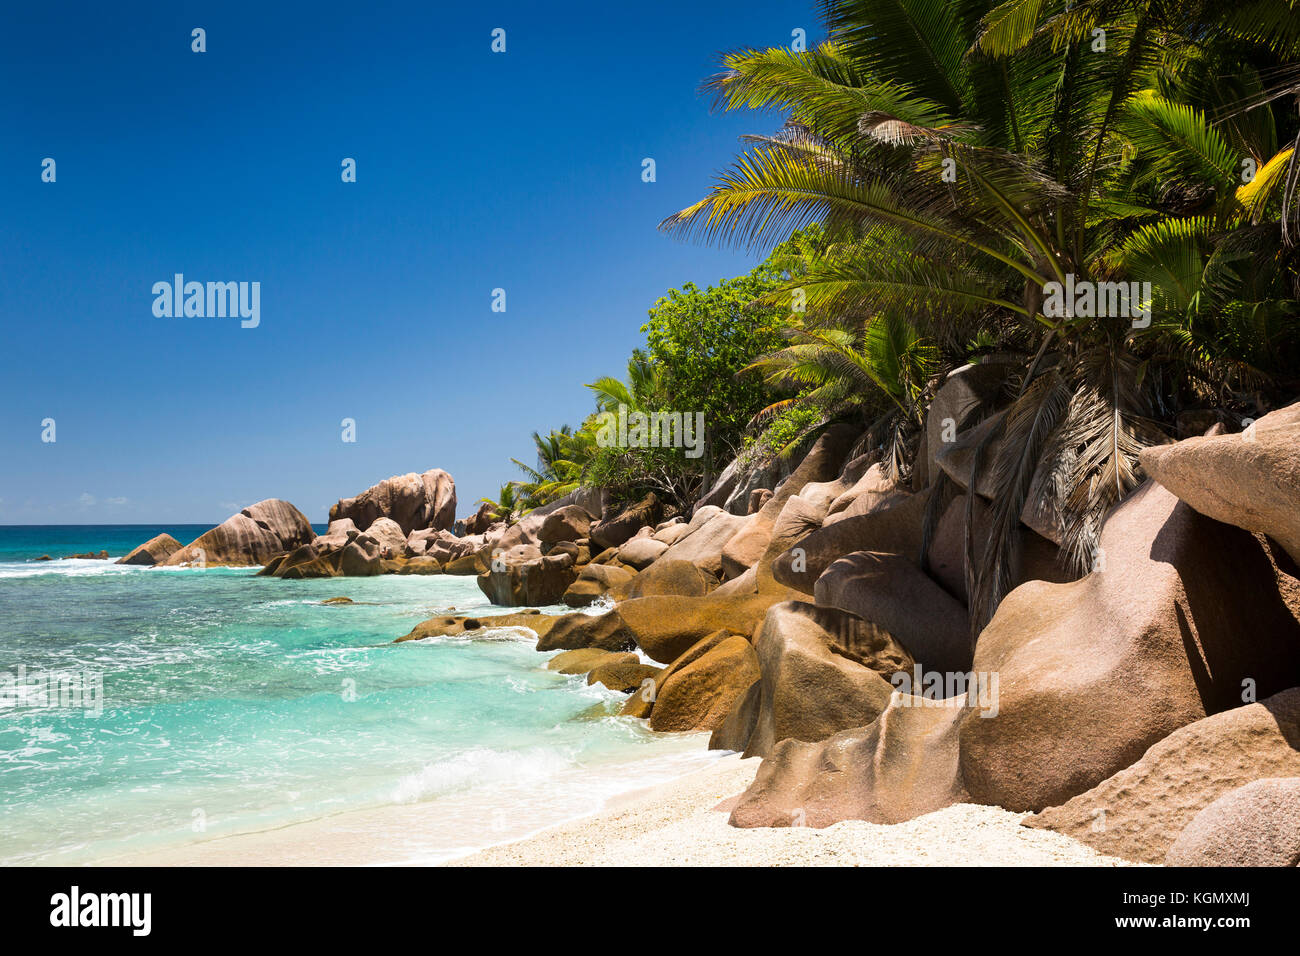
962,483,1300,810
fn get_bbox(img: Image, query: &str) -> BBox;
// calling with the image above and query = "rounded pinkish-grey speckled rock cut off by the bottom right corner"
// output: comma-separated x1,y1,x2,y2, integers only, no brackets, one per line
1165,777,1300,866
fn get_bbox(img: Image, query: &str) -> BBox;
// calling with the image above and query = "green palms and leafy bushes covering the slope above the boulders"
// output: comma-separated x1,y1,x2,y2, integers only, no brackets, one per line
491,0,1300,632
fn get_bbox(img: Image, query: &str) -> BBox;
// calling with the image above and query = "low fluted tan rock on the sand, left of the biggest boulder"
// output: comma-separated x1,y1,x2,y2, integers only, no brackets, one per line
731,693,966,827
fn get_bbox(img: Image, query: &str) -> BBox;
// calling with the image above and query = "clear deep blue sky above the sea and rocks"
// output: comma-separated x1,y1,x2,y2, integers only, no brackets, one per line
0,0,819,524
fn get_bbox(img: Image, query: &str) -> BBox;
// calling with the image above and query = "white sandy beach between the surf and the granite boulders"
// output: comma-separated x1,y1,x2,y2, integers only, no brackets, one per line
101,754,1132,866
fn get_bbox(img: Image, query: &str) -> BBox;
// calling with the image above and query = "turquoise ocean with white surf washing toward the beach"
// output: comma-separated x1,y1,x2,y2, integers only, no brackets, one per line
0,525,707,865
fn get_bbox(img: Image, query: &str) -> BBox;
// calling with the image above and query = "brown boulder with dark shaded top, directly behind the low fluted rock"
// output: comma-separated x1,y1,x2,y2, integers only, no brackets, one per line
745,601,915,756
